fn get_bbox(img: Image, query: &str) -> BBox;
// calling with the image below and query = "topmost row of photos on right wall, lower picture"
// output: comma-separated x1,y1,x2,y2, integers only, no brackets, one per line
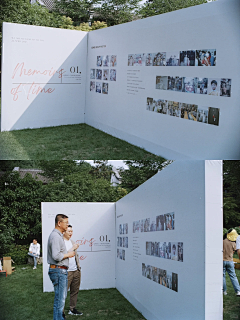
133,212,175,233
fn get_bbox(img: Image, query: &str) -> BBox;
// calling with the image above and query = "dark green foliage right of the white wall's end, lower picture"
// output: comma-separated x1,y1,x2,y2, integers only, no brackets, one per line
223,160,240,229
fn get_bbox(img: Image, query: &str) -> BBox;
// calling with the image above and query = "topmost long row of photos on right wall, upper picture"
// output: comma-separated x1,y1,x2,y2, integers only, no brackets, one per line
128,49,216,67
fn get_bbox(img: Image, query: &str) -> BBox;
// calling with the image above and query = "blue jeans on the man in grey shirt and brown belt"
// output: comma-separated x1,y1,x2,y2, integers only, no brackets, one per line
48,268,68,320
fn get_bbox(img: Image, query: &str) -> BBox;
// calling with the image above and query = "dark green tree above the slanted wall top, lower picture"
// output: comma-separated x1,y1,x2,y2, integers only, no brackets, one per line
120,158,171,192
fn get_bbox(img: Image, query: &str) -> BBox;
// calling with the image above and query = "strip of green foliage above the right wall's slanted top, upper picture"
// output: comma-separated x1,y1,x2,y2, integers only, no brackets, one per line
138,0,207,18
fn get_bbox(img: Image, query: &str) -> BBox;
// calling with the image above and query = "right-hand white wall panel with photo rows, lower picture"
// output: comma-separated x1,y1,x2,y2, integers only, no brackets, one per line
116,161,223,320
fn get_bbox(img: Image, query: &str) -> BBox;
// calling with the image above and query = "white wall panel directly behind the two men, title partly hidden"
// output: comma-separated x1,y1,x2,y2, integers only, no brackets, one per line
42,202,116,292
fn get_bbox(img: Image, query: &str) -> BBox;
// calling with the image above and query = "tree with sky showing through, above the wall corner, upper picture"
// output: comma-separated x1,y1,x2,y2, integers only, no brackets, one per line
93,0,140,26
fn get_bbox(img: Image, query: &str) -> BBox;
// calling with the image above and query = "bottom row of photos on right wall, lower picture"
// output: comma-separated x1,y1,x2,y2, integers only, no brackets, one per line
142,263,178,292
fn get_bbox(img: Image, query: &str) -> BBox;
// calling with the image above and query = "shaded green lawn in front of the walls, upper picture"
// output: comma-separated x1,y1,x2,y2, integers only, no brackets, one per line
0,124,163,160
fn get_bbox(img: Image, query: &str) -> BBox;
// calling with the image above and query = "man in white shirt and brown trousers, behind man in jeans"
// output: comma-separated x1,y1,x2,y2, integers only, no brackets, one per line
63,225,83,316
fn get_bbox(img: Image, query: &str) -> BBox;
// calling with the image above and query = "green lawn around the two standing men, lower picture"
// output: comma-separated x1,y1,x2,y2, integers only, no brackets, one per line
0,265,145,320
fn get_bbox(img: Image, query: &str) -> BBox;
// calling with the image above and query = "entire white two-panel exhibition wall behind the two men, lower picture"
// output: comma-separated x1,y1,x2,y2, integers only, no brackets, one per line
42,161,223,320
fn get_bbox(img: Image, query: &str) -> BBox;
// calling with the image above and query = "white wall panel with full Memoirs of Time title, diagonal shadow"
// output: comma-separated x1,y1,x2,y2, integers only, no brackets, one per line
1,23,87,131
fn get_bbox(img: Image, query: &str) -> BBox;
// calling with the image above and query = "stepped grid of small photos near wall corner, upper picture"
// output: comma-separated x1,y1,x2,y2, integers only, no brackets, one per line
90,55,117,94
